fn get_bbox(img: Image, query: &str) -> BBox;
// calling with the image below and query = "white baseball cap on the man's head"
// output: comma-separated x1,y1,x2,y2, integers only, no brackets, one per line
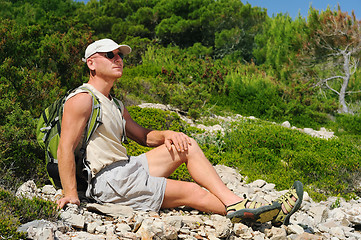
82,38,132,62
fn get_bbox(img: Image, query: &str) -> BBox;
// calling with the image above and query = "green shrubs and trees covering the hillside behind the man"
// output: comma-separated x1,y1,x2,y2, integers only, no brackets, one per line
0,0,361,237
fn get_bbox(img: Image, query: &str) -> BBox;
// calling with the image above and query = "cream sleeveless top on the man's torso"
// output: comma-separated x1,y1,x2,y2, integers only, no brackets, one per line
68,83,128,177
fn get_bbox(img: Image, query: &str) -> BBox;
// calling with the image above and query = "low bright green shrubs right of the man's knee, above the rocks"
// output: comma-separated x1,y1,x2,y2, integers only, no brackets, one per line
194,120,361,200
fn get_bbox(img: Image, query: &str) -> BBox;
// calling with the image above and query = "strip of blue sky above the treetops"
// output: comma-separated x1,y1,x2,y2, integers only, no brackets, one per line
242,0,361,20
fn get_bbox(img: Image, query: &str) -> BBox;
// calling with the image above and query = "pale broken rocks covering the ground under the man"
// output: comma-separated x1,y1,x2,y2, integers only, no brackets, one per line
17,165,361,240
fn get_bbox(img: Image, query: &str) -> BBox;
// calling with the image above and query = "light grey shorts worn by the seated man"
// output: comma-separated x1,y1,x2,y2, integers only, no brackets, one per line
93,154,166,212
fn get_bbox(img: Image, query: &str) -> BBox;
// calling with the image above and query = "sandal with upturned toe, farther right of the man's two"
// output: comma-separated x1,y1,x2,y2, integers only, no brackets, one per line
272,181,303,226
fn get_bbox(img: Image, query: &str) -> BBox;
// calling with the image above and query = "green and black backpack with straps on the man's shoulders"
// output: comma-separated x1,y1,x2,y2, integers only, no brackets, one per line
36,86,127,192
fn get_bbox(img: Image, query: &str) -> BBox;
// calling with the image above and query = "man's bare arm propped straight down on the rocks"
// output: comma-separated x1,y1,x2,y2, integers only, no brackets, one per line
58,93,92,208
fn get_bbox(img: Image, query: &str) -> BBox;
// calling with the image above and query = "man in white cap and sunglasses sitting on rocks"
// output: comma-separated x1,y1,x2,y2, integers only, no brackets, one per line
58,39,303,224
